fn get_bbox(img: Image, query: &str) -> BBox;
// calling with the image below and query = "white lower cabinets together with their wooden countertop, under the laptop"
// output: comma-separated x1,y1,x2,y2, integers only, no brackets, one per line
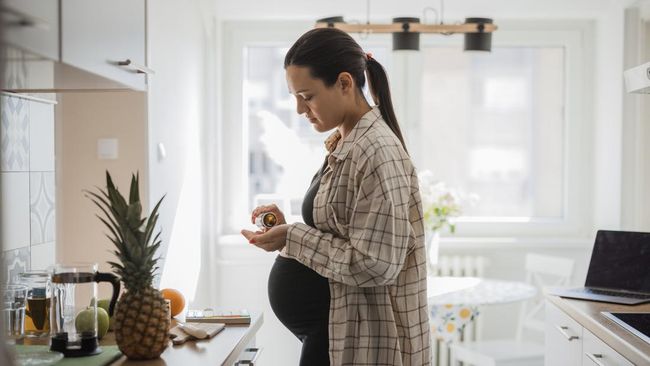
544,295,650,366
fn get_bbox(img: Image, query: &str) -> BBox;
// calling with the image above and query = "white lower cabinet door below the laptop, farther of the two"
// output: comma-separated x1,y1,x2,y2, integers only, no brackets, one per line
544,301,582,366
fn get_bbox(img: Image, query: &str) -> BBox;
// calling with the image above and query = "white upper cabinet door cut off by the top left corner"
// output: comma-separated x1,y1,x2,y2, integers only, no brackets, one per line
2,0,59,60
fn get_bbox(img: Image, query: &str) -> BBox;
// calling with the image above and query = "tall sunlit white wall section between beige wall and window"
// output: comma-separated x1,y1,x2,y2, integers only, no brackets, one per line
147,1,212,308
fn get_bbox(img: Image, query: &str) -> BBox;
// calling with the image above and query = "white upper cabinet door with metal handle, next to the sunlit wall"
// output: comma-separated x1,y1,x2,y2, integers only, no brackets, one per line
61,0,146,90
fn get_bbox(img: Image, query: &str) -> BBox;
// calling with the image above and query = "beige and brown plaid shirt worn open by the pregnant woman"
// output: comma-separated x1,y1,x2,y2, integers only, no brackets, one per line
283,107,430,366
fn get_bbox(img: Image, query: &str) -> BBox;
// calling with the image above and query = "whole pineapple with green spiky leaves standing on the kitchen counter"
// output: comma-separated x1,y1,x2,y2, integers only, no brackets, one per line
87,171,170,360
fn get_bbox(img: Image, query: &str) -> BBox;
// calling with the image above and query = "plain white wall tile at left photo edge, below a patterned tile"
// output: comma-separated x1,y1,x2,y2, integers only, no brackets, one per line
0,172,30,250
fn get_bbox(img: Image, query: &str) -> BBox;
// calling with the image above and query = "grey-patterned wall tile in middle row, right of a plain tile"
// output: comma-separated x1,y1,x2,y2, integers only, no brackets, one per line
29,172,56,244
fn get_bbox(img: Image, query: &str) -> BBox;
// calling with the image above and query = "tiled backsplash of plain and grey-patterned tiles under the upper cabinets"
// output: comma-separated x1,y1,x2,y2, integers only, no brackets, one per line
0,95,56,281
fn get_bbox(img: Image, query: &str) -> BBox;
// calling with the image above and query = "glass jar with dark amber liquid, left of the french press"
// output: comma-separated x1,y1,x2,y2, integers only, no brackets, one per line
18,271,52,337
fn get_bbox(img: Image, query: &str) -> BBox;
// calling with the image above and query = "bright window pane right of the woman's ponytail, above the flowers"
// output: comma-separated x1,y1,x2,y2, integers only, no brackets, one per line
411,46,565,220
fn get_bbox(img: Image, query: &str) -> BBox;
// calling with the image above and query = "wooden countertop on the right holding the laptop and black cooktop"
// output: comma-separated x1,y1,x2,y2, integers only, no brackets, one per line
546,295,650,365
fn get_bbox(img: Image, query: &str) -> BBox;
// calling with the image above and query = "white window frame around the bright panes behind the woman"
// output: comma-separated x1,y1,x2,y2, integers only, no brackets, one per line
217,20,594,242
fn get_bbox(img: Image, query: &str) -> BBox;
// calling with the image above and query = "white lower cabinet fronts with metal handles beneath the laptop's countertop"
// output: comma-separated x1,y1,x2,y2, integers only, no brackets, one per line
544,301,633,366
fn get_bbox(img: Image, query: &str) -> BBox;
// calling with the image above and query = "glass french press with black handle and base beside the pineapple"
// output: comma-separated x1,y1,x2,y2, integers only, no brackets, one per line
50,263,120,357
